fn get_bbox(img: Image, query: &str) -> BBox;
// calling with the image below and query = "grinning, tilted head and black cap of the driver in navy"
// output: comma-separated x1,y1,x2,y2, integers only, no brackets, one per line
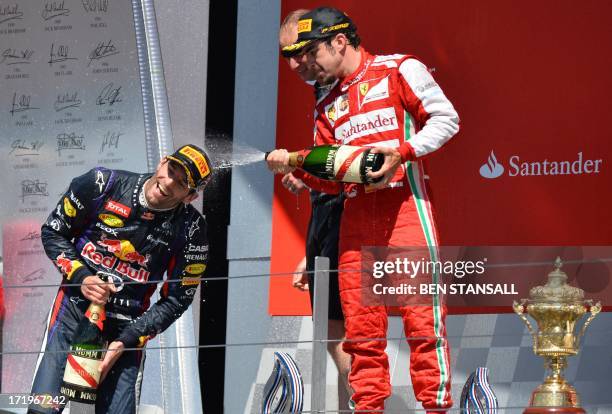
144,144,212,210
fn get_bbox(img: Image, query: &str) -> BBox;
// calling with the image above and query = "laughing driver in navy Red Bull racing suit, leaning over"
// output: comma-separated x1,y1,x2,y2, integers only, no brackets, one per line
28,145,212,414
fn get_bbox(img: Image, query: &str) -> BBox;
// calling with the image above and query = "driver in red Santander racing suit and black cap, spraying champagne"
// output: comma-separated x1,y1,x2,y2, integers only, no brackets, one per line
268,8,459,410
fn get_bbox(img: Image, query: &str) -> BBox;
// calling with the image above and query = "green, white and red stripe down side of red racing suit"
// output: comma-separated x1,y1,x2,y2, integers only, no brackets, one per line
404,111,450,405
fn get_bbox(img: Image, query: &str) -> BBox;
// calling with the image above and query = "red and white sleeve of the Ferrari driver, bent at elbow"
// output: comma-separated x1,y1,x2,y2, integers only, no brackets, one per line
399,59,459,162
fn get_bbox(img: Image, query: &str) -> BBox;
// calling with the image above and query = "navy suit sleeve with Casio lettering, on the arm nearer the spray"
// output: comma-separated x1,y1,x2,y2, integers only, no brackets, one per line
117,209,208,348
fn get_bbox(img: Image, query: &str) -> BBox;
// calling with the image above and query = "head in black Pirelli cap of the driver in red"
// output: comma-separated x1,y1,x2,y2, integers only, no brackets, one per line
282,7,361,84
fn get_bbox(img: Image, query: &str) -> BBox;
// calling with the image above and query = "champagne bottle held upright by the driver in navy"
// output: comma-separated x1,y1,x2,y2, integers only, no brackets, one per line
60,277,107,404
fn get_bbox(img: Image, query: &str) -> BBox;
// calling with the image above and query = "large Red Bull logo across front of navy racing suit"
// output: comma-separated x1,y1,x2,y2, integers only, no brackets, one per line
81,243,151,282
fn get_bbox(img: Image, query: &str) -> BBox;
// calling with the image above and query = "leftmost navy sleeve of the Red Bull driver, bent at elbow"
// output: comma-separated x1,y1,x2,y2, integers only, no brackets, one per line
41,168,111,283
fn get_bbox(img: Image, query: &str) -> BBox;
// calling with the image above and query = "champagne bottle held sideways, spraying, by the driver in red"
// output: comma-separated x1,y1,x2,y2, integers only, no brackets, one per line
266,145,385,184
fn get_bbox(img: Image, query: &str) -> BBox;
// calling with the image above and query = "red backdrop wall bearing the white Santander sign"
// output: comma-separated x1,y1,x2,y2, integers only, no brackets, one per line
269,0,612,315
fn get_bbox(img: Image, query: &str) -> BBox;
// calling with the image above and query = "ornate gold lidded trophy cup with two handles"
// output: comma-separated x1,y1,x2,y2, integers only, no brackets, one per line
513,257,601,414
